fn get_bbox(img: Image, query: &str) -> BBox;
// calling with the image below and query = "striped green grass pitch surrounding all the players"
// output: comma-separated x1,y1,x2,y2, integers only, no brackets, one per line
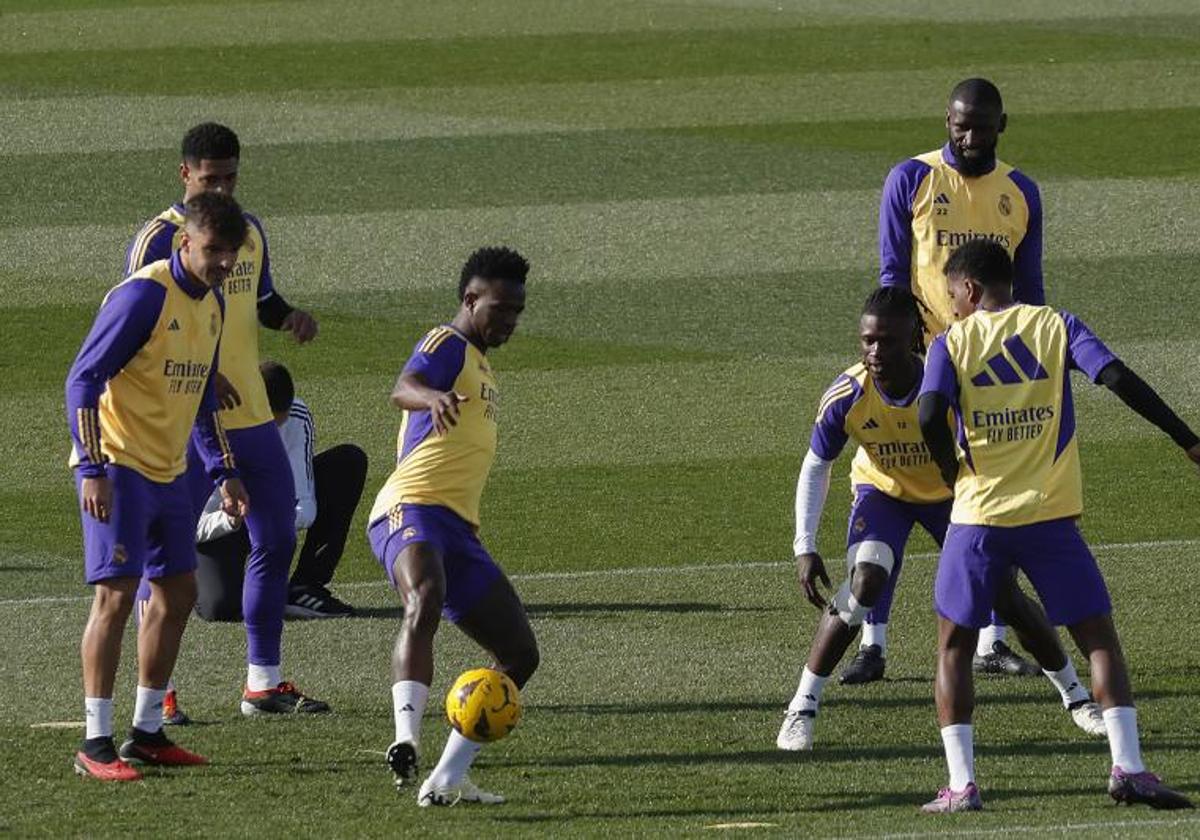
0,0,1200,838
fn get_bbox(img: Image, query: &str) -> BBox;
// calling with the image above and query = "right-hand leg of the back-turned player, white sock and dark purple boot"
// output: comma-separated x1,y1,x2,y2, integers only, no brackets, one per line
1068,613,1193,809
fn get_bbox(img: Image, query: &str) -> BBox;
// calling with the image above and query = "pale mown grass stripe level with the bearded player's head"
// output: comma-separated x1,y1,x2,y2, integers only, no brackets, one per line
9,60,1200,157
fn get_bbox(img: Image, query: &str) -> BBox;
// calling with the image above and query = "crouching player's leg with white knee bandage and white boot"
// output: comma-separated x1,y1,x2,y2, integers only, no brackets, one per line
775,554,892,751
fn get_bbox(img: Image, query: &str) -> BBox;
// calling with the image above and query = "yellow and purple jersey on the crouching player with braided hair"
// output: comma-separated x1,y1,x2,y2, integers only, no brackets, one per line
809,364,950,504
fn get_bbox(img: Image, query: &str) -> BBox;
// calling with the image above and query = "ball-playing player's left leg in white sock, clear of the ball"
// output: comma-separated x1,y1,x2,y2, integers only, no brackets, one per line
388,542,446,787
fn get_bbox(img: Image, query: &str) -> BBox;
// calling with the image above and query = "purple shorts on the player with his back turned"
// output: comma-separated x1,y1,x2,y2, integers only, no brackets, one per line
934,518,1112,628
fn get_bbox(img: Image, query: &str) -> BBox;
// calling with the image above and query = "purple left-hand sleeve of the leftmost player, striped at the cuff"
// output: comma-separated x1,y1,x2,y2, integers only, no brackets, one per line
66,280,167,476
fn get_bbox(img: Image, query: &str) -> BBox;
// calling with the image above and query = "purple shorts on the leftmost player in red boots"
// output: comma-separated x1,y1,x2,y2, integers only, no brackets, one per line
76,464,196,583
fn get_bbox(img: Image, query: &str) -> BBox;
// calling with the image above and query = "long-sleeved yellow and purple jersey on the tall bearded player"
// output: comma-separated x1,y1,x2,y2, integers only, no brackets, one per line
880,146,1045,341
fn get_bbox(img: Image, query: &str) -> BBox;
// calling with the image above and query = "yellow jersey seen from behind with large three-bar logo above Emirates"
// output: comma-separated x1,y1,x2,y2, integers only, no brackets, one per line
922,304,1116,527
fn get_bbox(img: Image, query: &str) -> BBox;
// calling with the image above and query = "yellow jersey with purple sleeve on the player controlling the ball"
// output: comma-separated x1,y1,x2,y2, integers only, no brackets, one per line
368,326,500,526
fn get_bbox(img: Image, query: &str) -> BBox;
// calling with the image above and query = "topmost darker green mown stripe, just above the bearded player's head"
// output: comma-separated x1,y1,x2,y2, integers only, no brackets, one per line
0,17,1200,96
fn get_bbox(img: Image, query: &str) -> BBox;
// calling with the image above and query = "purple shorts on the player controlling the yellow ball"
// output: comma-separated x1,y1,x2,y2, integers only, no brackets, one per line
367,504,504,623
